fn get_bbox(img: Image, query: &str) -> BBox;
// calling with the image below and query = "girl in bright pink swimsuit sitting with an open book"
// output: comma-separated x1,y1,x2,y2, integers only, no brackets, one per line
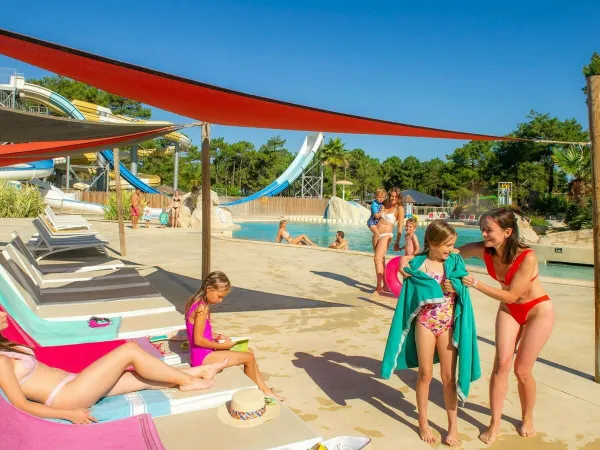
185,272,283,400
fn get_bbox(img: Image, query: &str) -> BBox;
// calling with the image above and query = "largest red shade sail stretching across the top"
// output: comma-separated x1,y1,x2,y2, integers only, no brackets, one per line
0,29,514,140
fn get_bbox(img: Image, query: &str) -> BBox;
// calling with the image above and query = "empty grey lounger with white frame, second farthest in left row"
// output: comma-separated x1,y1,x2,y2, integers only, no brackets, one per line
27,219,108,261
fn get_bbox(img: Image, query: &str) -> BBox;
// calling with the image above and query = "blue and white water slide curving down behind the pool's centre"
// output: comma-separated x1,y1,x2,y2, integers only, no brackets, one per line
219,133,324,206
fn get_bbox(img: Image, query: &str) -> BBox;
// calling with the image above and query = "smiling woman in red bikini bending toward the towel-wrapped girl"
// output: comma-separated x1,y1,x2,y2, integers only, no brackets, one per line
401,208,554,444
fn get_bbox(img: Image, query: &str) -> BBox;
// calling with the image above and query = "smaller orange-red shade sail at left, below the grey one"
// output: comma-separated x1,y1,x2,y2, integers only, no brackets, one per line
0,125,183,167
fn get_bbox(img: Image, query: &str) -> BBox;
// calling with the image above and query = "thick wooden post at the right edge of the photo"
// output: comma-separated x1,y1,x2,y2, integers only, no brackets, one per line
587,75,600,383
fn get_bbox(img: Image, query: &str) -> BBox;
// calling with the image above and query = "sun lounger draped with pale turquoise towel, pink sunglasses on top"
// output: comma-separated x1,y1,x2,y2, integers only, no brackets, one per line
0,267,185,346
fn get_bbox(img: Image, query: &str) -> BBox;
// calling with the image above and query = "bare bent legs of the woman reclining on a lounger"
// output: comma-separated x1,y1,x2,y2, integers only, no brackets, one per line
52,343,214,409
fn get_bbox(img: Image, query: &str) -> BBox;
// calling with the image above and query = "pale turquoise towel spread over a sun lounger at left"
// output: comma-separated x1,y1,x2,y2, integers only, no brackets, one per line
0,267,121,347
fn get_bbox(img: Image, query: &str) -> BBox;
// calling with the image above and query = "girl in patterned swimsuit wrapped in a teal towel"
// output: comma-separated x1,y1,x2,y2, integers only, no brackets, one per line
382,220,481,446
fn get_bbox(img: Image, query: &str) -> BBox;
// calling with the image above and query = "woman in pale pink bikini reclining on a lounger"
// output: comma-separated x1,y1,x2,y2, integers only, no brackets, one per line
0,314,229,424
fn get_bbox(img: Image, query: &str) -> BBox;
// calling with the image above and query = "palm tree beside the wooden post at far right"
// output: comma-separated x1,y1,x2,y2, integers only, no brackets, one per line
552,145,592,204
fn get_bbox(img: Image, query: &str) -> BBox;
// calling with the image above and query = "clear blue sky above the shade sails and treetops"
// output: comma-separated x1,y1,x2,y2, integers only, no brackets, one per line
0,0,600,160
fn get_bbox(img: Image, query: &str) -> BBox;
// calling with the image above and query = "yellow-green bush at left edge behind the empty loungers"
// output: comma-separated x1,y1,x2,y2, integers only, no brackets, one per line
0,181,44,219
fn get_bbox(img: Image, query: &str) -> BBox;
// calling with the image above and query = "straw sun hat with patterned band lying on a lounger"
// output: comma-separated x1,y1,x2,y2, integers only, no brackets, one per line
217,389,281,428
